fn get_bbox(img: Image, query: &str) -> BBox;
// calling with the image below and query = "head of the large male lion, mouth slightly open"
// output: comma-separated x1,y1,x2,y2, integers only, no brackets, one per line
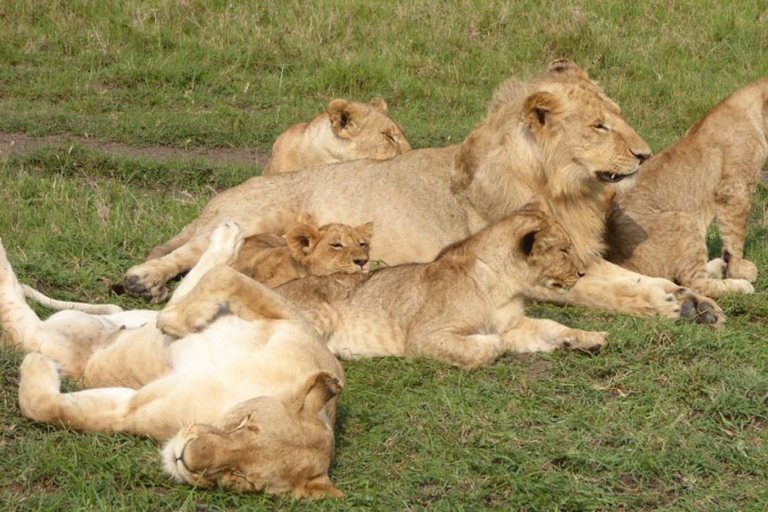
454,60,651,206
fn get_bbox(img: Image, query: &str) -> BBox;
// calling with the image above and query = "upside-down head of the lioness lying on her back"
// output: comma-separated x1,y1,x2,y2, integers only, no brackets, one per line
162,372,342,498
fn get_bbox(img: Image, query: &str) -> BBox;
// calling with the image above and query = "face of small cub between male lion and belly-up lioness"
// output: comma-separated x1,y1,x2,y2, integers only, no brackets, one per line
285,219,373,276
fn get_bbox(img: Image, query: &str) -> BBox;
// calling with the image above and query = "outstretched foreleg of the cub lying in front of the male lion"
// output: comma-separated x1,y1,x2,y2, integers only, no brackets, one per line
503,316,608,353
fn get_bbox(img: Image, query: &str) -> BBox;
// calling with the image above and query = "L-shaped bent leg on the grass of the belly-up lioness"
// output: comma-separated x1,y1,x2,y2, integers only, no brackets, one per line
19,352,136,432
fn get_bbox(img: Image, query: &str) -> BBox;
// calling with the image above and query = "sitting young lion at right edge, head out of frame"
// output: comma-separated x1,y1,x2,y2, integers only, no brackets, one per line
607,78,768,296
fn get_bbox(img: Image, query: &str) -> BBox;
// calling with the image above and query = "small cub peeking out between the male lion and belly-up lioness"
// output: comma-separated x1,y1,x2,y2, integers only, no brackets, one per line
233,215,373,288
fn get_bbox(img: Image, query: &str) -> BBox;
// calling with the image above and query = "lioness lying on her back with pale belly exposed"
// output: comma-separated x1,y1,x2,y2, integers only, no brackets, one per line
0,223,343,498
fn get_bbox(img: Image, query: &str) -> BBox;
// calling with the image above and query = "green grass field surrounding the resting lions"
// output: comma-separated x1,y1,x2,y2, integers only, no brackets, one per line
0,0,768,511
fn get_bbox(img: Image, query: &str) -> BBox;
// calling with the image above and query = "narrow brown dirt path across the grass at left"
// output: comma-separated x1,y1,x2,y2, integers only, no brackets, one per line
0,133,269,167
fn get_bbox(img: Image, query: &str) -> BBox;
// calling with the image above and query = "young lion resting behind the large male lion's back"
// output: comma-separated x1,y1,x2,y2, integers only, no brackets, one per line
262,98,411,176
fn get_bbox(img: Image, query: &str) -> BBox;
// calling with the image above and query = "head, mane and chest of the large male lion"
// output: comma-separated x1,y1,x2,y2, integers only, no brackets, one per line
451,60,651,260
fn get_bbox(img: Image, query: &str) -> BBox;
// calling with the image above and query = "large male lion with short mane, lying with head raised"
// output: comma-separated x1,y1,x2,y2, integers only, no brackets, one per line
125,60,725,324
